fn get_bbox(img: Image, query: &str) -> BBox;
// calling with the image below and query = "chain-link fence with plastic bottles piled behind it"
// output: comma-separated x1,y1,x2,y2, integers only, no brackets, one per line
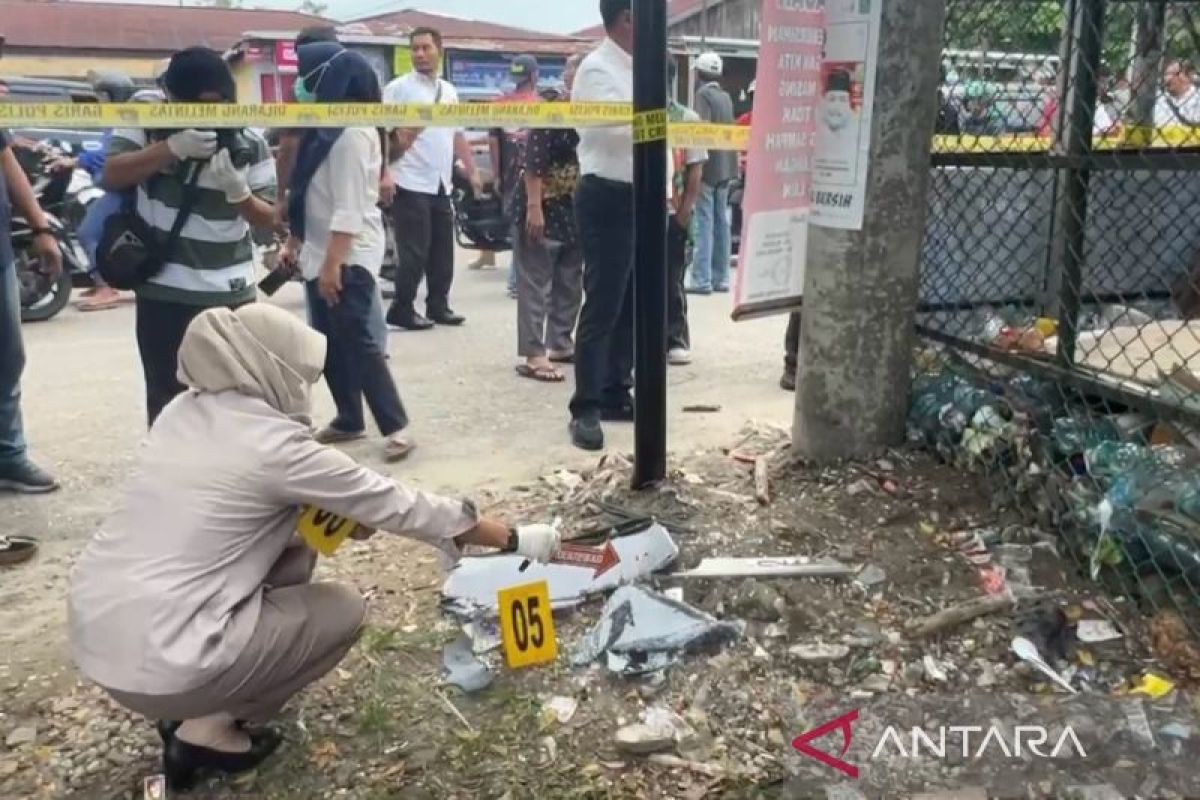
912,0,1200,628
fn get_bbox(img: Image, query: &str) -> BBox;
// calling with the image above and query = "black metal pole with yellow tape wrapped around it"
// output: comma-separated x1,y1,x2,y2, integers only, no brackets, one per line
631,0,667,489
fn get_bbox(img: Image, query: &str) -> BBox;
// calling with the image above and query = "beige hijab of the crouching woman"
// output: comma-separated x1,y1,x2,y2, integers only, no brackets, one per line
179,303,325,423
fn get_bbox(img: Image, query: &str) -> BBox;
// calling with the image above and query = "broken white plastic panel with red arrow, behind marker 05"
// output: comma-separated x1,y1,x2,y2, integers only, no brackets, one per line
442,523,679,614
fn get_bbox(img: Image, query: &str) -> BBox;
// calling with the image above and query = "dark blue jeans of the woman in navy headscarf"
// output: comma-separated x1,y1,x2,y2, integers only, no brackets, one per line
305,266,408,437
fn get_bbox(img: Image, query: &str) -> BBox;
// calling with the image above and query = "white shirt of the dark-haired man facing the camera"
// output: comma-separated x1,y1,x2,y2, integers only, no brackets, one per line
383,72,458,194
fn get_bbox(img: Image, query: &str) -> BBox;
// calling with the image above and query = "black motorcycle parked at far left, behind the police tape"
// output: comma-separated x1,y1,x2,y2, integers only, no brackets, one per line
12,143,93,323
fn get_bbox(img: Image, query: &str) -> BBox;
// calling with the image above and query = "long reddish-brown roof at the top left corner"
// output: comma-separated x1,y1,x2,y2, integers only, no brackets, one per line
0,0,330,53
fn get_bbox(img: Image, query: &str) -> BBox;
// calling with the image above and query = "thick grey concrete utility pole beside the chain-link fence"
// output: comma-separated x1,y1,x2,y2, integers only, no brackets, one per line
792,0,946,462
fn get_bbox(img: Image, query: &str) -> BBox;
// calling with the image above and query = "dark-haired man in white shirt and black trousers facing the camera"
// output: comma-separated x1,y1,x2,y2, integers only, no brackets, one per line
383,28,480,331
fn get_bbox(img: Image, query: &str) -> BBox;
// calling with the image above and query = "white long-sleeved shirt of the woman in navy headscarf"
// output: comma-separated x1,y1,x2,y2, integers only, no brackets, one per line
300,128,386,281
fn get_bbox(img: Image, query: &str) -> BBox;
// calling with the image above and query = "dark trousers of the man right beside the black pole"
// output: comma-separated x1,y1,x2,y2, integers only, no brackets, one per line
571,175,634,419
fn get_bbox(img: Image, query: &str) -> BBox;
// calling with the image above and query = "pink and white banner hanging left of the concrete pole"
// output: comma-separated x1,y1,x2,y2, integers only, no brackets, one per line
733,0,824,319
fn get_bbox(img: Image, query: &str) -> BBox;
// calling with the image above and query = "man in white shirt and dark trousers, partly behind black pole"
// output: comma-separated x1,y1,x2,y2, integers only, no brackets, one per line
571,0,638,450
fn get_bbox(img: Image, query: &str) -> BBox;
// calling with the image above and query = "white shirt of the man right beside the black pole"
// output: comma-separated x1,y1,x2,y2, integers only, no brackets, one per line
571,38,634,184
